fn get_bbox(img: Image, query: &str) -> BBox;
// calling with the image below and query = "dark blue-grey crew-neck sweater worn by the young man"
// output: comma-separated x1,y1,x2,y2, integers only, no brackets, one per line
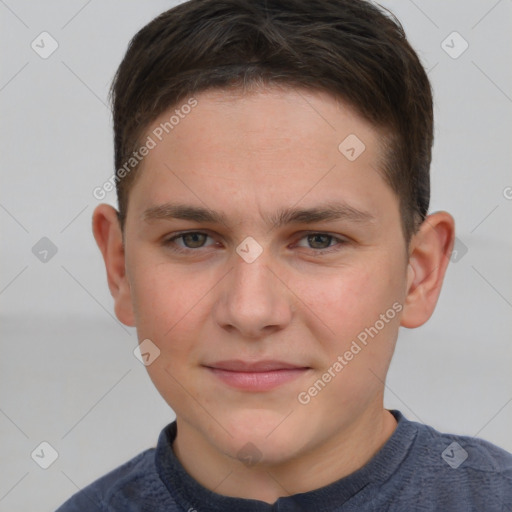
57,410,512,512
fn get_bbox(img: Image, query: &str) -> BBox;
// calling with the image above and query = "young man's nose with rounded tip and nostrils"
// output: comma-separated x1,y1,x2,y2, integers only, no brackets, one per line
214,251,293,339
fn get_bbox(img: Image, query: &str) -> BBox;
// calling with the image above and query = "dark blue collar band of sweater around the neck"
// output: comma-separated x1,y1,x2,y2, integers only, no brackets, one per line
155,409,418,512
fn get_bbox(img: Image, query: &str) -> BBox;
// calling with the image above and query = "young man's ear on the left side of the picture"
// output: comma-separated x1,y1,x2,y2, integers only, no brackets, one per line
92,204,135,327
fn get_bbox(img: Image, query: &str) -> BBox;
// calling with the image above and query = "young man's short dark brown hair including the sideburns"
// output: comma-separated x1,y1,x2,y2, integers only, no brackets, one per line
111,0,433,242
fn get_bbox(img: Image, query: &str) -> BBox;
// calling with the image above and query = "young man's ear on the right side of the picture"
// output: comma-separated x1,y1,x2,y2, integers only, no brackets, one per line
400,212,455,328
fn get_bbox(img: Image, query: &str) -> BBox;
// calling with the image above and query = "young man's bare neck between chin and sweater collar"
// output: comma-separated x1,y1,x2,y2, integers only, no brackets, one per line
173,407,397,504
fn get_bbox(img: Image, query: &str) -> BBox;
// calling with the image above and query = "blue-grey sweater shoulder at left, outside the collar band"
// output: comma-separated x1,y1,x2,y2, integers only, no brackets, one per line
56,448,174,512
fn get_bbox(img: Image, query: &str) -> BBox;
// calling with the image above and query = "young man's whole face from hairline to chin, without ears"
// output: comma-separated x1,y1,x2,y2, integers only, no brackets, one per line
125,88,407,462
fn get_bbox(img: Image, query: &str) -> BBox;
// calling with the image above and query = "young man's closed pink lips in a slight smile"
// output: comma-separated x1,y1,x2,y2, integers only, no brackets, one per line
204,360,311,392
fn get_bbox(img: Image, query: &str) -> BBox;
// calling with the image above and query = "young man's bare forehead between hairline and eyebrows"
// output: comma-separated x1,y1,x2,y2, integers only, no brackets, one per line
130,88,394,227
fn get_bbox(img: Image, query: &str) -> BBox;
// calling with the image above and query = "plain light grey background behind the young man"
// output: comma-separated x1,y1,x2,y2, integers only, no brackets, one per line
0,0,512,511
